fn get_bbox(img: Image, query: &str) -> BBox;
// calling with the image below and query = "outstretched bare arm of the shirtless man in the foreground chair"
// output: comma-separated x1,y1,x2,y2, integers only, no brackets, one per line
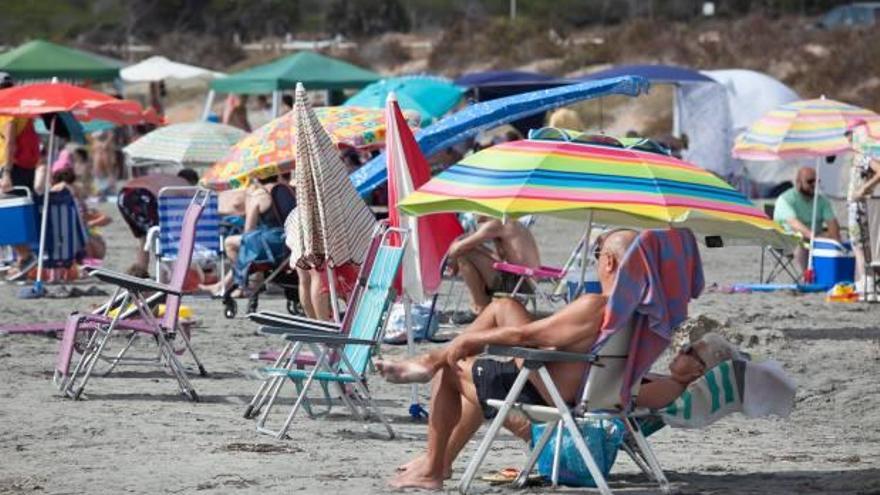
446,295,605,365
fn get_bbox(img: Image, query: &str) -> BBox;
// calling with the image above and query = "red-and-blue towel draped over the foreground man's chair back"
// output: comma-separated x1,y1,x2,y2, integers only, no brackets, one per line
594,229,704,404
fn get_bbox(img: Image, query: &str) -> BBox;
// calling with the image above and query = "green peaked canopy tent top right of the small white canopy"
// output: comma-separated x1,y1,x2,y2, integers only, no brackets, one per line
211,51,382,94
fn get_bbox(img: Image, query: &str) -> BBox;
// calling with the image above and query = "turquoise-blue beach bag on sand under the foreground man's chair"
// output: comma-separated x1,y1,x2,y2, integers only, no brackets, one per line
532,418,626,487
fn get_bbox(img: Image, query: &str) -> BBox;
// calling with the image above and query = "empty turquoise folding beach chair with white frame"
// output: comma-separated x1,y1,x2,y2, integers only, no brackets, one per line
248,228,407,439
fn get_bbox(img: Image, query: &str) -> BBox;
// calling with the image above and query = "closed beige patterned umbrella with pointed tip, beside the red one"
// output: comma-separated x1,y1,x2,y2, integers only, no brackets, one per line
285,85,376,281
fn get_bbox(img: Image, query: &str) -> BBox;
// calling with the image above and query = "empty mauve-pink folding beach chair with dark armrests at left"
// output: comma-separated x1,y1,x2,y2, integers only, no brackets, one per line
55,190,210,401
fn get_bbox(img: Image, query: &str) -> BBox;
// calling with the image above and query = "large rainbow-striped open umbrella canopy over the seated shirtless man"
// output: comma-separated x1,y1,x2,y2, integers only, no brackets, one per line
399,140,792,247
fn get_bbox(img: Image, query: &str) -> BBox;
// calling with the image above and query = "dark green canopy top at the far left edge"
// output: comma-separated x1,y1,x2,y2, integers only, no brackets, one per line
0,40,123,82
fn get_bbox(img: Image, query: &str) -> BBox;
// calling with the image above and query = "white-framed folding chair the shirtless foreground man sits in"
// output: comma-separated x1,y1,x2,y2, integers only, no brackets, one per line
459,231,703,495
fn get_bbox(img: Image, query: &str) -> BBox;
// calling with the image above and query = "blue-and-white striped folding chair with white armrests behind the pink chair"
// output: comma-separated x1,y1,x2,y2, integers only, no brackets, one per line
147,187,226,281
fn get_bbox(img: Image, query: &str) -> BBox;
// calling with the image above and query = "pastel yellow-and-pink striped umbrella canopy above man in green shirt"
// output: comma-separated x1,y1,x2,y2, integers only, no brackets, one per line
733,98,880,161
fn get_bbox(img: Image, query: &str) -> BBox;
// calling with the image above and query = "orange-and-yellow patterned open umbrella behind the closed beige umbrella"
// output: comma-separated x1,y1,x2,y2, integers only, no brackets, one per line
202,107,419,191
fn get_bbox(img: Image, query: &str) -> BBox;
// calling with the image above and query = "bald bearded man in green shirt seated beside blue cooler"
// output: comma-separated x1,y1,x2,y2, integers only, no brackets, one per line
773,167,840,269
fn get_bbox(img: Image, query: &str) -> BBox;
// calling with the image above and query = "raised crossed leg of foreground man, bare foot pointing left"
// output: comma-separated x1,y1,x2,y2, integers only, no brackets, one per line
376,298,532,383
